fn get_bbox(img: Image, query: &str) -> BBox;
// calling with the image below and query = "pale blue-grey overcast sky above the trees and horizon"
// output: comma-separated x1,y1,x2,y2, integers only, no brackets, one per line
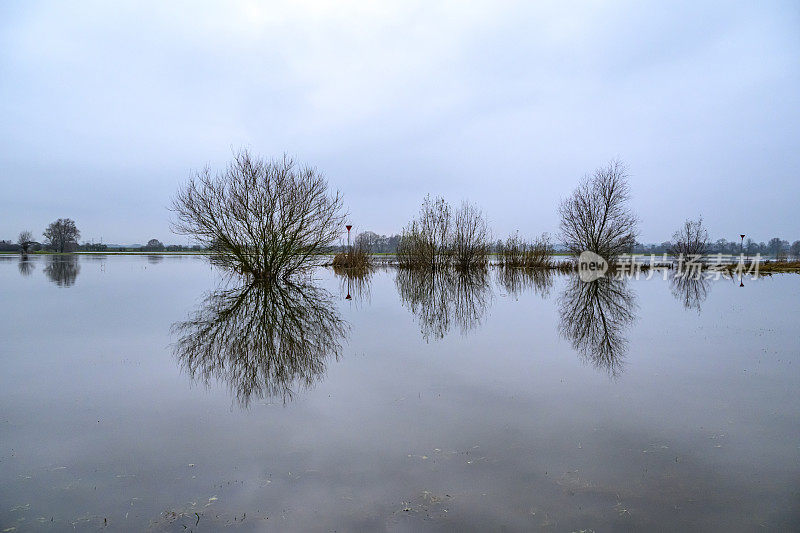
0,1,800,243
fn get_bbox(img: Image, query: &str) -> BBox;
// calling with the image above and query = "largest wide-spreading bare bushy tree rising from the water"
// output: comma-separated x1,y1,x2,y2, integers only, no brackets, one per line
172,150,346,280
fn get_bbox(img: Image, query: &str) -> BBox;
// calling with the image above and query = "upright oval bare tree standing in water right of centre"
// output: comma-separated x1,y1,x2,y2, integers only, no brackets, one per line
559,160,639,262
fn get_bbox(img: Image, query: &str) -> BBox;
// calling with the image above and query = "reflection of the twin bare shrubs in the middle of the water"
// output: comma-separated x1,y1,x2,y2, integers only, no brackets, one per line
395,268,492,341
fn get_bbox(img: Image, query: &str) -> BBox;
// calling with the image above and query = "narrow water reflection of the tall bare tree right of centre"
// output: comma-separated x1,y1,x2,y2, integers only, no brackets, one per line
558,276,636,376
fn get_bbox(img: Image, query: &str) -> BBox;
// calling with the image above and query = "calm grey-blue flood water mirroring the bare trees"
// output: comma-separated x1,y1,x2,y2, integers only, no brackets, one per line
0,256,800,531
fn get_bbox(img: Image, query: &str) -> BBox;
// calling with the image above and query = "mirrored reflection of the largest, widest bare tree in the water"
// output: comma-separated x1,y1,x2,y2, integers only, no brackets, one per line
173,282,347,407
